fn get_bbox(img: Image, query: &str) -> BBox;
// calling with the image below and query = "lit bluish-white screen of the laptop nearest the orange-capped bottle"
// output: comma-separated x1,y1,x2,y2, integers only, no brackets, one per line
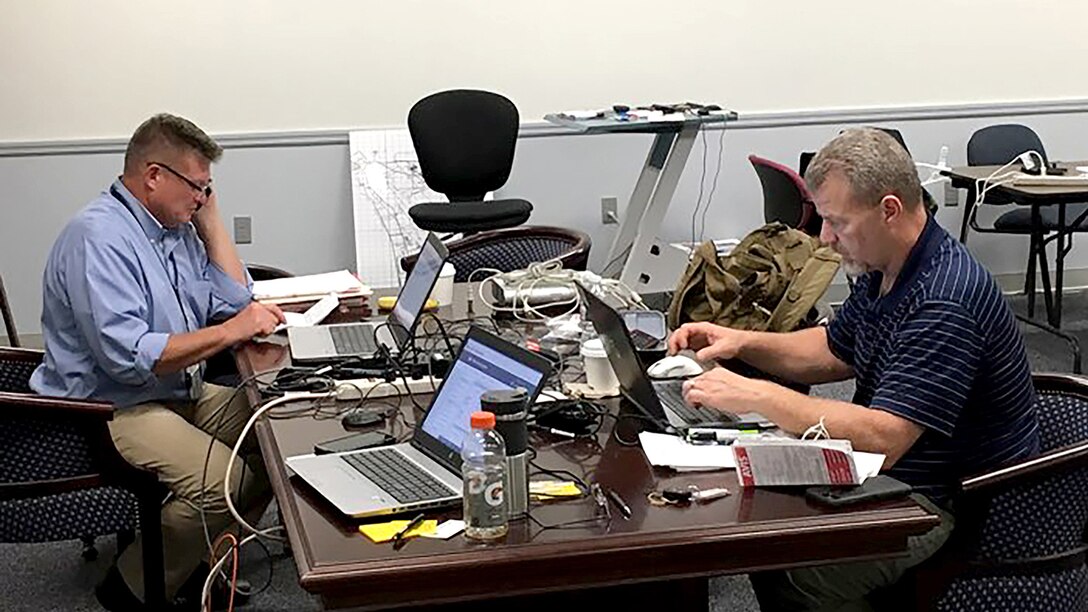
417,328,551,463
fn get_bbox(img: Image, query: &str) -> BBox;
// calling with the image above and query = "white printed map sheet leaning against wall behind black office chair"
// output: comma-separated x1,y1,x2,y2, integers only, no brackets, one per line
348,128,446,287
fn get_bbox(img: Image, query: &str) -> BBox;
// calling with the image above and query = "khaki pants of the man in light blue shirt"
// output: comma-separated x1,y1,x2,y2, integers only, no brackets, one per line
110,384,271,599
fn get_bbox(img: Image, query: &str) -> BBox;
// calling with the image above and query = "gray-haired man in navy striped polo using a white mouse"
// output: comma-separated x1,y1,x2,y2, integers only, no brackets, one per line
669,130,1039,610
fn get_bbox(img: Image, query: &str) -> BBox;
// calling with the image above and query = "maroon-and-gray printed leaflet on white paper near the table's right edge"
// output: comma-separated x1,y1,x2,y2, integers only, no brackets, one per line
732,437,885,487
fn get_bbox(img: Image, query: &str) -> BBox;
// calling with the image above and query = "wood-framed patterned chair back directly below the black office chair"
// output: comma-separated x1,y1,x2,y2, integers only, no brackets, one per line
400,225,592,282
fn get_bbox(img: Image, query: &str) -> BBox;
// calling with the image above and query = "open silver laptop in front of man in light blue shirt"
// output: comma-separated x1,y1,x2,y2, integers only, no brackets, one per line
287,233,449,362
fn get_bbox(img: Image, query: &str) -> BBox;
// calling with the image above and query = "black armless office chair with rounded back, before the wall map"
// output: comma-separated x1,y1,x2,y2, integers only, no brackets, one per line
408,89,533,233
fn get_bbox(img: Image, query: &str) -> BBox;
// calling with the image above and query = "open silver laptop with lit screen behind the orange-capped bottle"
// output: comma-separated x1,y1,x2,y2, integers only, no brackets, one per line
285,328,552,517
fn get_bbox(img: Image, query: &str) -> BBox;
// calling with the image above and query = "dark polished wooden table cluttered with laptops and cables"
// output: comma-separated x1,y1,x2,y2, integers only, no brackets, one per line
237,290,938,611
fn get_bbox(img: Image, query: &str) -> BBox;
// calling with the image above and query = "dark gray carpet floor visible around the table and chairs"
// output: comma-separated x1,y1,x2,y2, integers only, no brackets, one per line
0,294,1088,612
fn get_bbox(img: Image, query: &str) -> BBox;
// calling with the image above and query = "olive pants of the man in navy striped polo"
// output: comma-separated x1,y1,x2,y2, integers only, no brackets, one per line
749,494,954,612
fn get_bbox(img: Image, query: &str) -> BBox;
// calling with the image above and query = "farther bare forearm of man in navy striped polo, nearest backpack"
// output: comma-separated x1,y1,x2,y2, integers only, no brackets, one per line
737,327,853,384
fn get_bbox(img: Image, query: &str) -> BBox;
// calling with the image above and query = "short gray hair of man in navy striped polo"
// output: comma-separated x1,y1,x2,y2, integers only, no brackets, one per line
805,127,922,209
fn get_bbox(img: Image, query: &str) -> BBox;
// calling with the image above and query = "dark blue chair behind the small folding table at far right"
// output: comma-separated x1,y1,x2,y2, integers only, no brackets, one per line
960,123,1088,324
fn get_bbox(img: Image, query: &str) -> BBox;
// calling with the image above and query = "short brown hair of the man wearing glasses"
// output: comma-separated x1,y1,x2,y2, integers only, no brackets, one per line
125,112,223,173
